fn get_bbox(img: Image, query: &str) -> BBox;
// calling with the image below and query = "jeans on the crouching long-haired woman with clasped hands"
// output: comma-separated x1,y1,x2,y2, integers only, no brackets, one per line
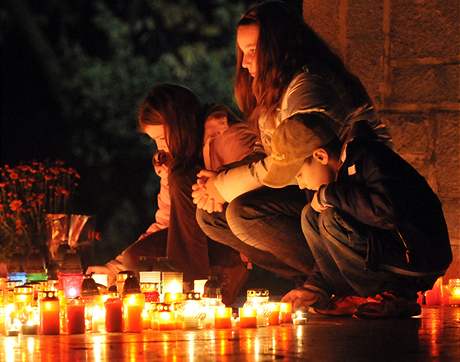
197,186,313,278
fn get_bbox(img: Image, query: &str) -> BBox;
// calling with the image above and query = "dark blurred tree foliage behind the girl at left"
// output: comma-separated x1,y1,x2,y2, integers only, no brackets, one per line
0,0,249,262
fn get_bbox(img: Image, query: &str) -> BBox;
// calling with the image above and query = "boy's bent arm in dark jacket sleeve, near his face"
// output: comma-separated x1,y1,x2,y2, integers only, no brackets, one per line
318,142,404,229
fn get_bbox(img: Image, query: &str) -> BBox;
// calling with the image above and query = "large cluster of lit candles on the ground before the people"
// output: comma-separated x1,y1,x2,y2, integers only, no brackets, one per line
0,272,298,335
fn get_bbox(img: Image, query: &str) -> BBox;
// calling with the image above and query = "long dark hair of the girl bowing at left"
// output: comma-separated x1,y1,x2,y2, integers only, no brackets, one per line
138,83,204,168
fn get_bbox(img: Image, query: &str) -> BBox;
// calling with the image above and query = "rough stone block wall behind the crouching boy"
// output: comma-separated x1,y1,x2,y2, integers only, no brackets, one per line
303,0,460,278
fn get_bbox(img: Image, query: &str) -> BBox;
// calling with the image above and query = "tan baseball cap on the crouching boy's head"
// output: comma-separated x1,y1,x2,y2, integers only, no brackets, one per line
263,112,341,188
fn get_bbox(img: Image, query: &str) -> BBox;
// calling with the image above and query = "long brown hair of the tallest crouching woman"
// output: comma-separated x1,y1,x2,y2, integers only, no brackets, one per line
234,0,368,129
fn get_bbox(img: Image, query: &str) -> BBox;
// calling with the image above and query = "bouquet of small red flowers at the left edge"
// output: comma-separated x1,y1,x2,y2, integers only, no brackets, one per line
0,161,80,261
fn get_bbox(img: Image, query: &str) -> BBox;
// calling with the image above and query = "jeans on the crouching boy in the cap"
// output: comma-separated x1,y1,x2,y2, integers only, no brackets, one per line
302,205,437,298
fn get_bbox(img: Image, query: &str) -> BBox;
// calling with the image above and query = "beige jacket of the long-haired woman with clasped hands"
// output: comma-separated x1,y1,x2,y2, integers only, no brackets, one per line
215,69,391,202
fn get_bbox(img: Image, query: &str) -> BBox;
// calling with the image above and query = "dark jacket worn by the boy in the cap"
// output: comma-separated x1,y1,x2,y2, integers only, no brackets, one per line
323,122,452,276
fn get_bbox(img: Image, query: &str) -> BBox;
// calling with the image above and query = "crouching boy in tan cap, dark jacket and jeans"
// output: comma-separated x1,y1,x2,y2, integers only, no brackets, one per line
264,113,452,318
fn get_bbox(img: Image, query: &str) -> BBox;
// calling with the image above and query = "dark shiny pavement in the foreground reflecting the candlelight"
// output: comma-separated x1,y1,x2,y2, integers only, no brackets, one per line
0,307,460,362
